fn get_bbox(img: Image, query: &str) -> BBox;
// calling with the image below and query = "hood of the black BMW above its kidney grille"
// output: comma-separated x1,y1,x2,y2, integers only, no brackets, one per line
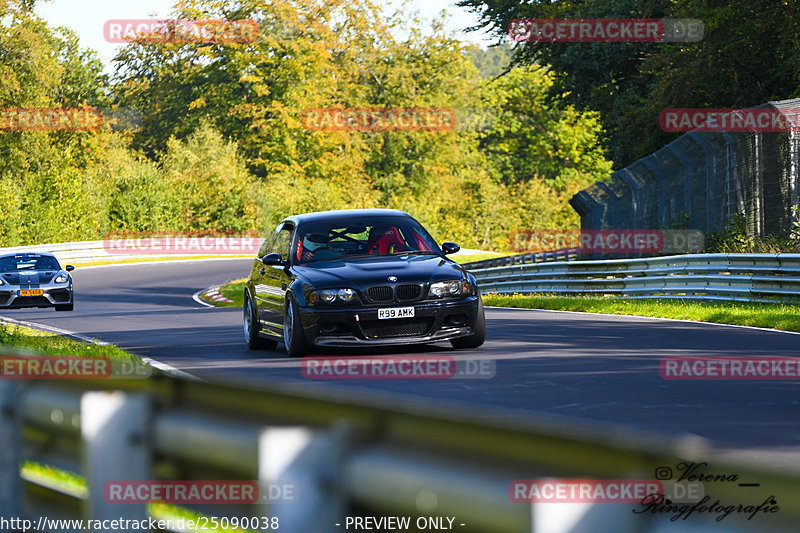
293,255,464,288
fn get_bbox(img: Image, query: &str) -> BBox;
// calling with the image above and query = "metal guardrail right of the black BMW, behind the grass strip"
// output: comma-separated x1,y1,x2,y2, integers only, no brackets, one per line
471,254,800,302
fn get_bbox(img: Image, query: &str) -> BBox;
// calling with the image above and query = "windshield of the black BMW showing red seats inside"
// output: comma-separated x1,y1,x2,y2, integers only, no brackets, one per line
295,217,440,264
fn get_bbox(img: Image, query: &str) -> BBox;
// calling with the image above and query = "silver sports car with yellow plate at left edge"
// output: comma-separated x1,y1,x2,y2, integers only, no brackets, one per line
0,253,75,311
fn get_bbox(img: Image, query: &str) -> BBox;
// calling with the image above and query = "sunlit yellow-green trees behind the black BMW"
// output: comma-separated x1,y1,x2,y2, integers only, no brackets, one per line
0,0,611,250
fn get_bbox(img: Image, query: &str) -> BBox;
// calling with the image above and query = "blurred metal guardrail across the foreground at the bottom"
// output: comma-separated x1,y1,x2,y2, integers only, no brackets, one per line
0,376,800,533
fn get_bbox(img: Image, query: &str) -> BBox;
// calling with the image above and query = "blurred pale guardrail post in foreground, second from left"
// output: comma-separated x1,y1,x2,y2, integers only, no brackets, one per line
81,391,151,533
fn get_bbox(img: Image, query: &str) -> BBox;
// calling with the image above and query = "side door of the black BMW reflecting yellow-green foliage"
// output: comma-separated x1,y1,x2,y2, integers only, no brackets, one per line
259,222,294,333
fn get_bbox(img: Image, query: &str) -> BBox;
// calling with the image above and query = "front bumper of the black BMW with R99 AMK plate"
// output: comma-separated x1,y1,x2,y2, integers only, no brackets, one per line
300,296,478,346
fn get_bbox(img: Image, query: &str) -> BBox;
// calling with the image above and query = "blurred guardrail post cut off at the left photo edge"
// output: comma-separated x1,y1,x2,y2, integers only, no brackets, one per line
0,379,22,520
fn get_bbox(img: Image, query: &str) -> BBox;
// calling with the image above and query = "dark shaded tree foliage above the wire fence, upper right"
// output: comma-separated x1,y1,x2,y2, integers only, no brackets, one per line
458,0,800,169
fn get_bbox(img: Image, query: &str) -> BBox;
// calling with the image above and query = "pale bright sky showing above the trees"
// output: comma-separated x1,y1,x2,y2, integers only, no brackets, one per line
36,0,493,74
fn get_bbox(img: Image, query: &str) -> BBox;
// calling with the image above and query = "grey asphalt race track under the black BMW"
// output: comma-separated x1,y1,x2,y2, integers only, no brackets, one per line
3,259,800,454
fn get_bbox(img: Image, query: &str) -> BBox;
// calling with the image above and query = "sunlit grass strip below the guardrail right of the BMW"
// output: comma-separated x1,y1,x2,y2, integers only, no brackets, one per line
483,294,800,332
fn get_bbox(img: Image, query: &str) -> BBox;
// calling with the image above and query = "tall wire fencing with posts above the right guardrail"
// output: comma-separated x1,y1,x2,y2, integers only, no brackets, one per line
570,99,800,249
